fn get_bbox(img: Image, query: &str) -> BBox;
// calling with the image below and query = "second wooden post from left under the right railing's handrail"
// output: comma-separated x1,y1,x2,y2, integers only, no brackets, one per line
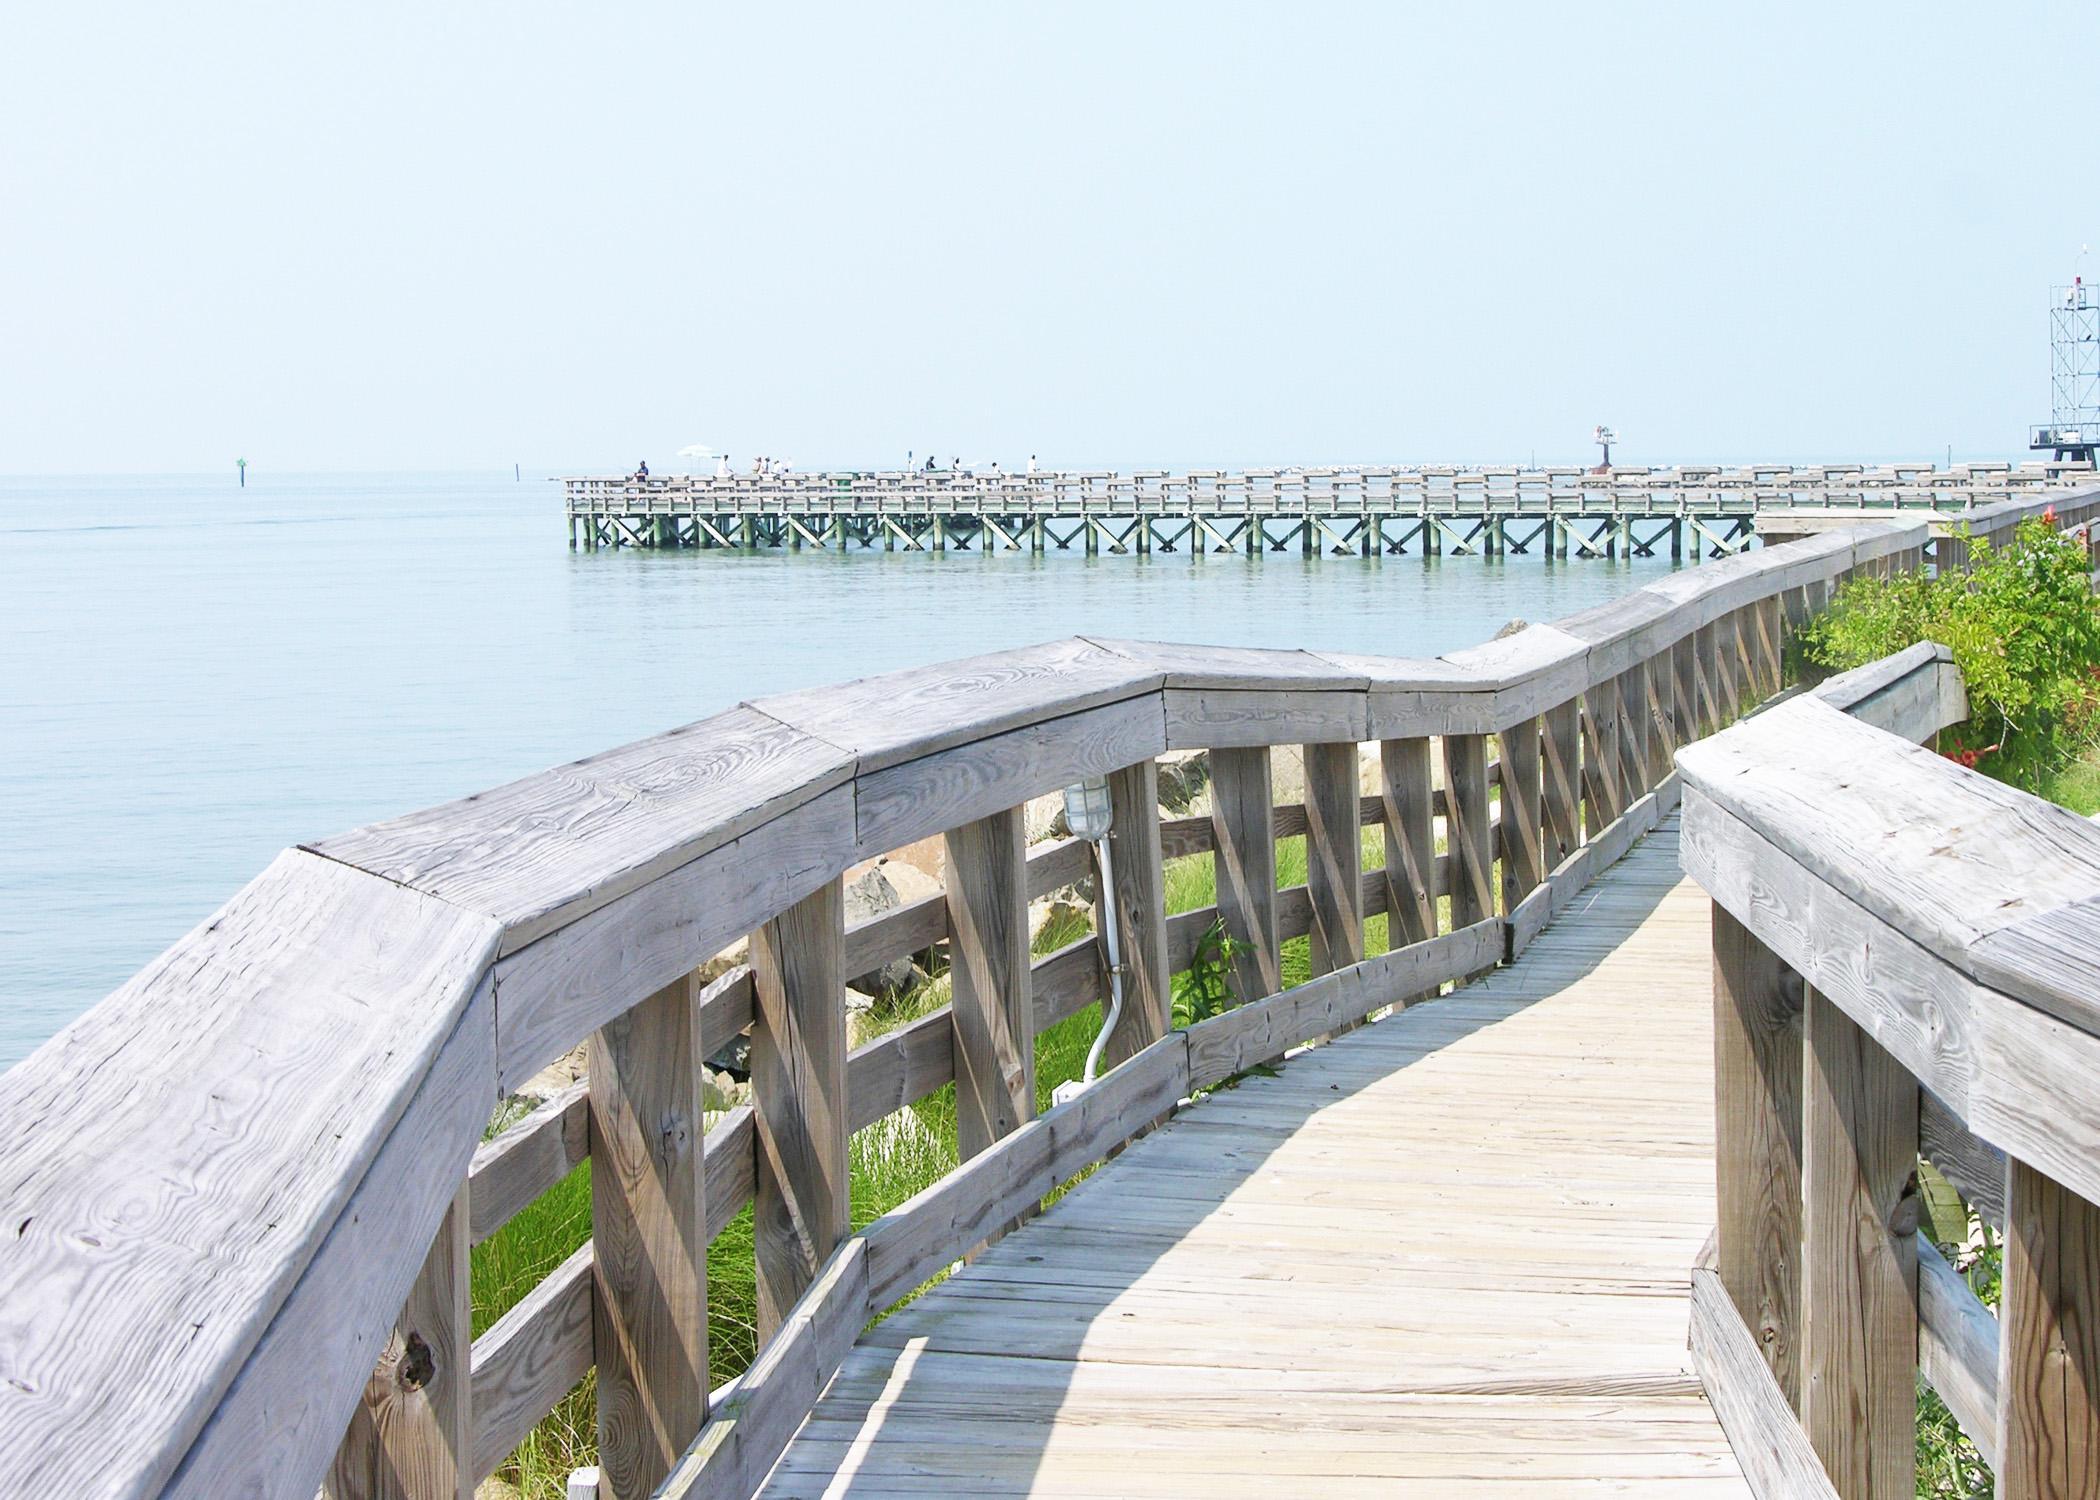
1800,989,1917,1500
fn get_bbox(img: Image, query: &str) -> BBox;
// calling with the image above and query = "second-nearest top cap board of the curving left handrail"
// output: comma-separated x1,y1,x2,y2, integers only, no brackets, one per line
309,708,855,954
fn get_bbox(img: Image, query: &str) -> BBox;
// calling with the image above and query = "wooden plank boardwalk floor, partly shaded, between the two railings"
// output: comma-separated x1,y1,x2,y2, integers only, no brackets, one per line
764,819,1749,1500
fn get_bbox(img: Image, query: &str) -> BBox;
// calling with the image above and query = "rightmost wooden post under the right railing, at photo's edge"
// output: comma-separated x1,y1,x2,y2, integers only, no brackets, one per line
1997,1158,2100,1500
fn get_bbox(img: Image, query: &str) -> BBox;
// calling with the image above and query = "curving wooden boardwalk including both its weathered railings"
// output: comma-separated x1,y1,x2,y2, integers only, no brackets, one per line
12,487,2100,1500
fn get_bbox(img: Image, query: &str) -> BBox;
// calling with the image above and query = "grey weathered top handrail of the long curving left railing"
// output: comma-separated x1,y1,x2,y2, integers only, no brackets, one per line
12,485,2066,1496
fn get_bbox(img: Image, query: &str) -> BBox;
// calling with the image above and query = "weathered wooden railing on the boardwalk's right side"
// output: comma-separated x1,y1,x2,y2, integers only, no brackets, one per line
1678,498,2100,1500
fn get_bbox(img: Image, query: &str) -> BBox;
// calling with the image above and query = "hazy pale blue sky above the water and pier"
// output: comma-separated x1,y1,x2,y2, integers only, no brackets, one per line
0,0,2100,471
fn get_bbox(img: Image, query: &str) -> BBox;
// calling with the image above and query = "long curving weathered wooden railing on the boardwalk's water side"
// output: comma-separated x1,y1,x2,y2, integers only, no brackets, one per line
0,492,2100,1500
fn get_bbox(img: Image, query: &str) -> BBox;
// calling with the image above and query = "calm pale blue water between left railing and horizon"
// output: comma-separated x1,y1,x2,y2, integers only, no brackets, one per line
0,475,1670,1067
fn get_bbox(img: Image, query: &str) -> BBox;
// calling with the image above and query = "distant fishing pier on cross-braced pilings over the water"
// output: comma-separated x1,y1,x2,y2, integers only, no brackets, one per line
561,462,2077,561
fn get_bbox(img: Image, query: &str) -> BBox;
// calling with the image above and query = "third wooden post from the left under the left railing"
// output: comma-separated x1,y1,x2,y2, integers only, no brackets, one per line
752,878,851,1345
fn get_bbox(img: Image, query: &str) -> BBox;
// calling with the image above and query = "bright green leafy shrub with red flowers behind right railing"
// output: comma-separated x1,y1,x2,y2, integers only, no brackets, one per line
1806,517,2100,790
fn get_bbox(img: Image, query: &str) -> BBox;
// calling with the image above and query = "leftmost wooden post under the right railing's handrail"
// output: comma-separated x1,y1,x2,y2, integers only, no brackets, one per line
1714,901,1802,1412
